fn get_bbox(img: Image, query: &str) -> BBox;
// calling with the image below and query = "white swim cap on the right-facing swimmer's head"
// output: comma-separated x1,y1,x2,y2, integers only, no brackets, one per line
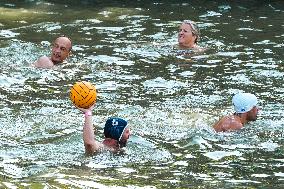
232,93,257,113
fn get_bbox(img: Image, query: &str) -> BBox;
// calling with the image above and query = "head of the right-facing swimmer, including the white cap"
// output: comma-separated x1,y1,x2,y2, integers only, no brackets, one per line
232,93,259,121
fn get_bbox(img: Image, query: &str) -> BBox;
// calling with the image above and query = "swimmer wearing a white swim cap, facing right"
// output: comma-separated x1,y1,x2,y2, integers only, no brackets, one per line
213,93,259,132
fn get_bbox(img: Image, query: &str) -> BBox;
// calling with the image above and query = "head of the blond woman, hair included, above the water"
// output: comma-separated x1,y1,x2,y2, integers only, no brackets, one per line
178,20,200,48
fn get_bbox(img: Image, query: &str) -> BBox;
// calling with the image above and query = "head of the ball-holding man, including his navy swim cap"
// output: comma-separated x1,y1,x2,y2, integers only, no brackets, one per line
104,117,130,147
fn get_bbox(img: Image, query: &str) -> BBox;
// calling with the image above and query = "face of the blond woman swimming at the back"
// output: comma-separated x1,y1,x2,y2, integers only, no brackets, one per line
178,23,197,48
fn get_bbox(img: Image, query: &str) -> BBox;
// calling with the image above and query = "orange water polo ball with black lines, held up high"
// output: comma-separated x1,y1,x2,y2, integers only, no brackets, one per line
70,81,97,109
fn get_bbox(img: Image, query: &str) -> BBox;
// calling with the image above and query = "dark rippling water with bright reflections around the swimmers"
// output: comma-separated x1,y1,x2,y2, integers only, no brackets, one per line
0,0,284,188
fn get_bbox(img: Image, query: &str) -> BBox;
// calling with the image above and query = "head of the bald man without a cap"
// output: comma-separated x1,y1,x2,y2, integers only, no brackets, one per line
51,36,72,64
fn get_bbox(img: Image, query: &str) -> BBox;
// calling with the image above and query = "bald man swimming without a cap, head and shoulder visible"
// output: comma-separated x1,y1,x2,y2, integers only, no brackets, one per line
33,36,72,68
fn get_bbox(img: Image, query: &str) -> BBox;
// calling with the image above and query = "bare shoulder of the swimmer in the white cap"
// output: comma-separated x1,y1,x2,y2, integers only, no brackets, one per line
213,115,243,132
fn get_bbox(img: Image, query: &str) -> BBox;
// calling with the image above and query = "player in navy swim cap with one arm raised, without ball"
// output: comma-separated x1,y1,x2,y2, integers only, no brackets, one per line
78,106,131,154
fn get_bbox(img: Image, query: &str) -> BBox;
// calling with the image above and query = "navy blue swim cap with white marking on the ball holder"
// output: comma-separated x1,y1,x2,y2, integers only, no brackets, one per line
104,117,127,141
